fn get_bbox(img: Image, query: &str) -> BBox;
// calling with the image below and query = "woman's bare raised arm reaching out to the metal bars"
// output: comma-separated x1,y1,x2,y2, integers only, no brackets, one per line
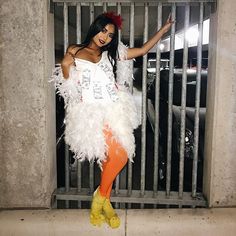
127,16,174,60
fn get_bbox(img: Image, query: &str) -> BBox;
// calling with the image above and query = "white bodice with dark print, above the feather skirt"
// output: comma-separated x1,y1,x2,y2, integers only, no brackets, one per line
75,52,118,103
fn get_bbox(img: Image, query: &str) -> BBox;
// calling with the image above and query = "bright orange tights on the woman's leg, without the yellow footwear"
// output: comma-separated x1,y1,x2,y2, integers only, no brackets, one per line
99,129,128,199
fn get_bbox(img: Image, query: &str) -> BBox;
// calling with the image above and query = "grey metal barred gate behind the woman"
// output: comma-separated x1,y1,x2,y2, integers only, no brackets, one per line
51,0,215,208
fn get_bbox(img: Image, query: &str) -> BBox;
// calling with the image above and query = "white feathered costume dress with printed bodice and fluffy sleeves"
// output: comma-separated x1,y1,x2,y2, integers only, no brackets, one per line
52,43,139,166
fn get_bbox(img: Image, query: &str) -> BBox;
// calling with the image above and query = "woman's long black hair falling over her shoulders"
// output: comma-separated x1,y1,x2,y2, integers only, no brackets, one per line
70,14,118,77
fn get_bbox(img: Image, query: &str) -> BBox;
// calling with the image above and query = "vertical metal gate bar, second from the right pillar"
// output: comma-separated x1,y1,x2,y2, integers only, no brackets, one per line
179,3,190,198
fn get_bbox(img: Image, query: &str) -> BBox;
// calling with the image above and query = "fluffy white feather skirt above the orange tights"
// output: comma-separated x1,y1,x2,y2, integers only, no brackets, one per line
65,91,139,165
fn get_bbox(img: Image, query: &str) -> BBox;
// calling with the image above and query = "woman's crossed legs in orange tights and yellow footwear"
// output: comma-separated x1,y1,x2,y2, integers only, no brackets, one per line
90,130,128,228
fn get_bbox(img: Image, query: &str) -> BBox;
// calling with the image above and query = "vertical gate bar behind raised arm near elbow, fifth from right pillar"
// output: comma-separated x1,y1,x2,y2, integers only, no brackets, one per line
140,3,148,208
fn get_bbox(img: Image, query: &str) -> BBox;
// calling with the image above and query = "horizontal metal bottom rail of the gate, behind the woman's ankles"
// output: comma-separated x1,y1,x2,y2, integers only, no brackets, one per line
53,188,207,207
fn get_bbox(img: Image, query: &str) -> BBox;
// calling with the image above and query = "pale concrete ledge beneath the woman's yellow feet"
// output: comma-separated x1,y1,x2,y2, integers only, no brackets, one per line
0,208,236,236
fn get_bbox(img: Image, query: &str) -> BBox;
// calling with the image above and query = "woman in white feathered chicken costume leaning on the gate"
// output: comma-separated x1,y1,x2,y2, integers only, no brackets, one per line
54,12,173,228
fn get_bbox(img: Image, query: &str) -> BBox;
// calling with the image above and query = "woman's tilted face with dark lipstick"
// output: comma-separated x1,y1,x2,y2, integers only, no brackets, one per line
93,24,115,47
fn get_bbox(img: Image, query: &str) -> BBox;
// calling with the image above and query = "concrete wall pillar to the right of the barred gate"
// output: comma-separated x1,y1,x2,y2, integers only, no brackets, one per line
204,0,236,206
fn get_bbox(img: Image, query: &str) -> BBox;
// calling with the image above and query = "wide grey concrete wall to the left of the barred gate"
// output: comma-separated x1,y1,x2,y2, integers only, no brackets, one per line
0,0,56,208
